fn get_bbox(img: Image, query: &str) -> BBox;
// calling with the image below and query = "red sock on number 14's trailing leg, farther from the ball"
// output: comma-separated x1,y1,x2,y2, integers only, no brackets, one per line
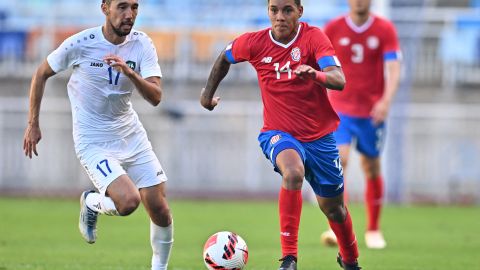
328,209,358,264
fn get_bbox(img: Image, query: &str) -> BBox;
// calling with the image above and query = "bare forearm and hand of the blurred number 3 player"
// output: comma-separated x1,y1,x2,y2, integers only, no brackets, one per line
371,61,400,125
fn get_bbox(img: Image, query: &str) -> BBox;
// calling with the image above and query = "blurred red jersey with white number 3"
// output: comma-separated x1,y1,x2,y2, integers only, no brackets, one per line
325,15,401,117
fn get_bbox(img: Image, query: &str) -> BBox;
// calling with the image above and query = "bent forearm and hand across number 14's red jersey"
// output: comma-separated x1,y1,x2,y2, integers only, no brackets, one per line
294,65,345,90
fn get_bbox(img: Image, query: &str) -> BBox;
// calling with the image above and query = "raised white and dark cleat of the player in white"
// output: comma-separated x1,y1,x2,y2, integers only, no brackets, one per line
78,190,98,244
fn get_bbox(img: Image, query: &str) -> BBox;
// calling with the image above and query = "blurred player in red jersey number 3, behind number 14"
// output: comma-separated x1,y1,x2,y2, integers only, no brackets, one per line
323,0,401,249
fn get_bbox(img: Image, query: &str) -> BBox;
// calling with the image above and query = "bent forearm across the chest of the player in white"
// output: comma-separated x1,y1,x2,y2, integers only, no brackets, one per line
103,55,162,106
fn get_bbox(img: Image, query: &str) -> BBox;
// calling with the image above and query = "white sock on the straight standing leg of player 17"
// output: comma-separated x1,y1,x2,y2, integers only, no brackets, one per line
150,220,173,270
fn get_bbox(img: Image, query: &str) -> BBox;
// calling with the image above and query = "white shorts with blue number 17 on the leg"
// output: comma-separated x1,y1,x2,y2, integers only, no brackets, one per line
76,132,167,194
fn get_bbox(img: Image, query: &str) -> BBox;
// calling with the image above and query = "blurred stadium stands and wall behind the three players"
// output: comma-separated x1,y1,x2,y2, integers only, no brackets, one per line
0,0,480,204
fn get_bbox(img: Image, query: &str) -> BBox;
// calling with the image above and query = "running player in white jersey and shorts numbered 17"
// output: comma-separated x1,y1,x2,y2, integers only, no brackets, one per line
23,0,173,270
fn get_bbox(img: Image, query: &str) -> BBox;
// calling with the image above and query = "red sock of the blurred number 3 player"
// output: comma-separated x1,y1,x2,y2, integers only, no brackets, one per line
365,176,383,231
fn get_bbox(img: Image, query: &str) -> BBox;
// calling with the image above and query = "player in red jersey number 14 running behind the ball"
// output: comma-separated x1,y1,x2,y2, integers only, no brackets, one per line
200,0,360,270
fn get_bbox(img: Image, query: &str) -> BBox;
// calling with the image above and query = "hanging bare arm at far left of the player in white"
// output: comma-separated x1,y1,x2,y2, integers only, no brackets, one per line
23,60,55,158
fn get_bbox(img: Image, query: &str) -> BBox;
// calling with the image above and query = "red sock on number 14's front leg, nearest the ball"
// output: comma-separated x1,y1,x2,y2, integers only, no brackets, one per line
278,187,302,257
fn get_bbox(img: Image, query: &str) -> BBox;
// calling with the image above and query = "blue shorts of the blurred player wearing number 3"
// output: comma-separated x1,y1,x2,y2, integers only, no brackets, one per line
333,113,386,158
